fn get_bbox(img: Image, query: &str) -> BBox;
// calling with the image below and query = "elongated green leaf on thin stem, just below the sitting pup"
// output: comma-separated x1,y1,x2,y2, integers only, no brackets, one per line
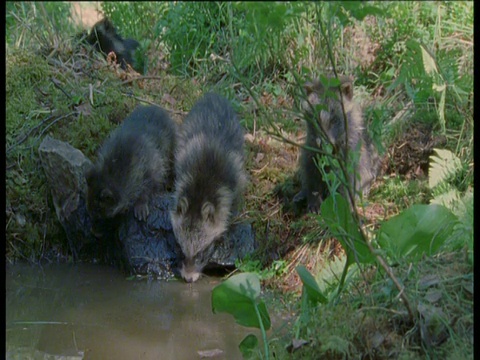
321,194,375,266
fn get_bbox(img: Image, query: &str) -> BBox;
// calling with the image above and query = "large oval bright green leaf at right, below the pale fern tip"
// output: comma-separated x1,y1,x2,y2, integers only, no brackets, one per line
378,204,458,261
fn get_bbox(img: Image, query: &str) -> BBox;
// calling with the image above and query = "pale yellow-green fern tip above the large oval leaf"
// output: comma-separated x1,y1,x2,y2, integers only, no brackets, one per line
428,149,462,189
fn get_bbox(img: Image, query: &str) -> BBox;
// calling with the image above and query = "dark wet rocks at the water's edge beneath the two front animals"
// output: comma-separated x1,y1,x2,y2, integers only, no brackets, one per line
39,136,256,279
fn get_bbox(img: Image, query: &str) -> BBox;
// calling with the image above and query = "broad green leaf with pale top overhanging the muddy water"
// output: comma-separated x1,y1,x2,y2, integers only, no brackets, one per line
212,273,271,330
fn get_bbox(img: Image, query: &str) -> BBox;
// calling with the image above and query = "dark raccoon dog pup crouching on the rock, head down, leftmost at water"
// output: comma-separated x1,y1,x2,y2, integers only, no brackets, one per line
85,106,176,228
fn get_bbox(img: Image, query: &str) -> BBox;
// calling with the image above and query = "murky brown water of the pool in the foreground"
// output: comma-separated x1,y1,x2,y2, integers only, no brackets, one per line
6,264,260,360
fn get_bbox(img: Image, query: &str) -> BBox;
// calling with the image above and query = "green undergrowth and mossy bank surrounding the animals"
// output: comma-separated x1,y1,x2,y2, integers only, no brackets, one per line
5,1,474,359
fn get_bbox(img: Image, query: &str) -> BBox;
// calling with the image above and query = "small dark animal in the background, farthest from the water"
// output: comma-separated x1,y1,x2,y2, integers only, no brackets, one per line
86,18,140,71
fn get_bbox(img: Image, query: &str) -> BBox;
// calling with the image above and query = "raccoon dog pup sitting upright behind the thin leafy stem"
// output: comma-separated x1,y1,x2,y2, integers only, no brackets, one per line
294,76,379,212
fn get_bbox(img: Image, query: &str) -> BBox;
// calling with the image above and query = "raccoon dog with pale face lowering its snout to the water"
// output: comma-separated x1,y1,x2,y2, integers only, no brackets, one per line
171,94,246,282
